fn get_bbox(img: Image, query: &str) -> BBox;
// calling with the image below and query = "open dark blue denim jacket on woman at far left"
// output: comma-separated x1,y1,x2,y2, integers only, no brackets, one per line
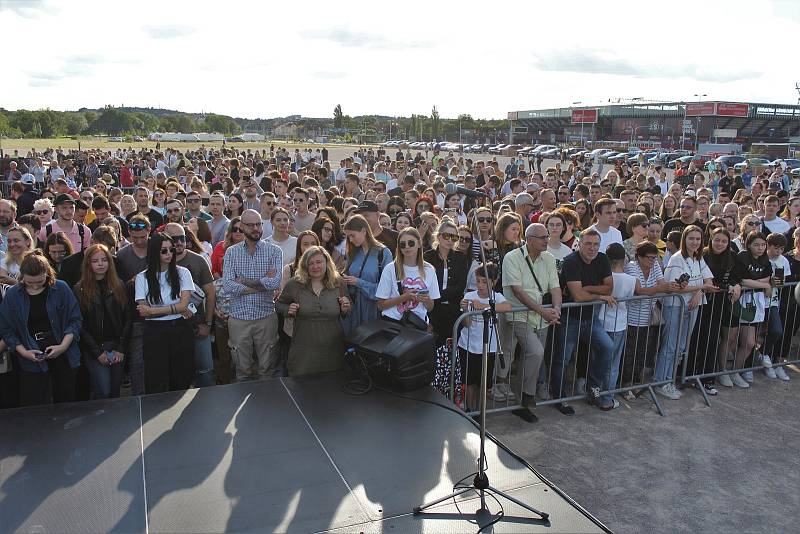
0,280,83,373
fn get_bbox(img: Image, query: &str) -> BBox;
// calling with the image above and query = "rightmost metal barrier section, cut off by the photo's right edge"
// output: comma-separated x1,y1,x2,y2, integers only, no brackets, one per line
681,282,800,406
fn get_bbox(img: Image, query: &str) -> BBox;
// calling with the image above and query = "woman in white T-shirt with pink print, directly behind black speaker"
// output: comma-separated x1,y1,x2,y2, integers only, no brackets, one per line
375,227,439,322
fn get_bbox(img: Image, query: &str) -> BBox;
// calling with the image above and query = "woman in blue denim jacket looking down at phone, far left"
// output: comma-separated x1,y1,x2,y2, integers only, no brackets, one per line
0,251,83,406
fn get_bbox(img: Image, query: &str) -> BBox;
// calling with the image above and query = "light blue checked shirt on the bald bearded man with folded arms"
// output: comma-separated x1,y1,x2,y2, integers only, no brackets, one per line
222,240,283,321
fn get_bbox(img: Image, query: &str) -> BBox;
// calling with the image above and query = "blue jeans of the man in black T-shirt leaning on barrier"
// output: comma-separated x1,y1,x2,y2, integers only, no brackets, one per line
550,310,613,405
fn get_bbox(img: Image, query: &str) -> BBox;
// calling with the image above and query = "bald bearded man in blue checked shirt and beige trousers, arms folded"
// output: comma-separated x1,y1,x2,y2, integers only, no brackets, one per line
222,210,288,381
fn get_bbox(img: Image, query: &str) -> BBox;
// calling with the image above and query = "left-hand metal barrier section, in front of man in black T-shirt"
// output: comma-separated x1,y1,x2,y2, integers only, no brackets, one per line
448,295,688,415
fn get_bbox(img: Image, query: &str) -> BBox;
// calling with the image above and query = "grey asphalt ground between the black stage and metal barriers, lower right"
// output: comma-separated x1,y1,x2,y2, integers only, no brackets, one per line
487,370,800,533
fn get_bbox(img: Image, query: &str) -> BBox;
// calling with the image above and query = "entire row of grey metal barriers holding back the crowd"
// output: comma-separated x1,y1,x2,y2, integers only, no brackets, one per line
446,282,800,415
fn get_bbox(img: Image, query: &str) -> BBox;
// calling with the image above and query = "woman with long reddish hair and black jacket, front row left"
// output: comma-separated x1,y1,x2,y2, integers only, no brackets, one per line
74,245,131,399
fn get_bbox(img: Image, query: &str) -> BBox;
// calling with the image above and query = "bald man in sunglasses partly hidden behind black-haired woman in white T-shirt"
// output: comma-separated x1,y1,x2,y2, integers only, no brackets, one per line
164,222,216,387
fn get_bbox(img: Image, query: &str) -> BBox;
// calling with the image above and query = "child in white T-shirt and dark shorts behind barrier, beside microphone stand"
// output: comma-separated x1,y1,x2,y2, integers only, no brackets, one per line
458,262,511,411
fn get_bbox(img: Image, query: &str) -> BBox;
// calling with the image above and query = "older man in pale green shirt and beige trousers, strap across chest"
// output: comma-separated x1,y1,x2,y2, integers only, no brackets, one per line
492,223,561,423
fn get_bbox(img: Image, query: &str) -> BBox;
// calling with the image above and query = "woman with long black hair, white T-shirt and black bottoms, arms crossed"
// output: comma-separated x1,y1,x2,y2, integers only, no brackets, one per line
135,233,194,393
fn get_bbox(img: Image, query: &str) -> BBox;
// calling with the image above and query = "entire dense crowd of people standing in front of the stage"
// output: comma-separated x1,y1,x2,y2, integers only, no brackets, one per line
0,147,800,421
